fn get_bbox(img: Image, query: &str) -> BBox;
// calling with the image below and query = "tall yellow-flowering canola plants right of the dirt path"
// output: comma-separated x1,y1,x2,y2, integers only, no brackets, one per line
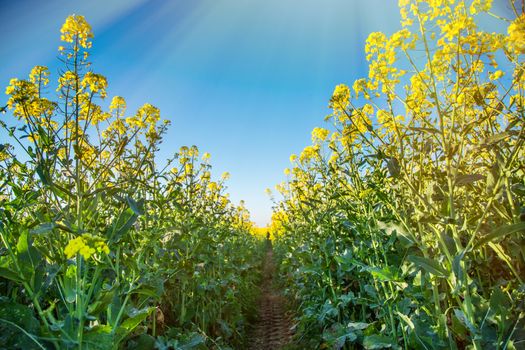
272,0,525,349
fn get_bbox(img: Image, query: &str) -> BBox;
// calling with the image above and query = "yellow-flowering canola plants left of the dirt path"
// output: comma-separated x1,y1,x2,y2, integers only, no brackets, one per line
0,16,260,349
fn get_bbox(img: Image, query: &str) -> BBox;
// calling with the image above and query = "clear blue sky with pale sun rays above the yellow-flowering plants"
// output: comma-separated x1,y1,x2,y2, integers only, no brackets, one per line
0,0,410,225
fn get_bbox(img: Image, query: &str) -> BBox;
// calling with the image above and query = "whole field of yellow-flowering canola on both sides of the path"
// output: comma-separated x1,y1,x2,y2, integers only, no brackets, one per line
0,0,525,350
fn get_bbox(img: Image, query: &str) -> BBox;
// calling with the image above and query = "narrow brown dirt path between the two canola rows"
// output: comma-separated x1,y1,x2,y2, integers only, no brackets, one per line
247,243,291,350
